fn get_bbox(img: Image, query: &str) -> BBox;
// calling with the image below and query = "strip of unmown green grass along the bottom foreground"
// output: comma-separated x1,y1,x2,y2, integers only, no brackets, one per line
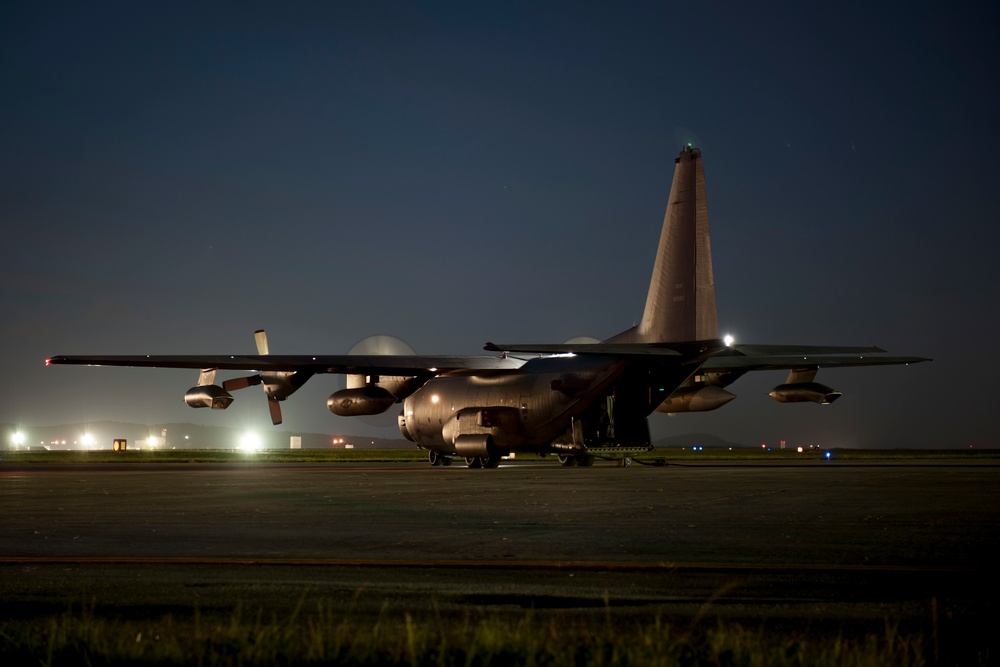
0,606,944,667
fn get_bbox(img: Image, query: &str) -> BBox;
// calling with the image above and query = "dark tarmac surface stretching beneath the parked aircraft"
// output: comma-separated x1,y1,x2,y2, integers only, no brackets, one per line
0,459,1000,647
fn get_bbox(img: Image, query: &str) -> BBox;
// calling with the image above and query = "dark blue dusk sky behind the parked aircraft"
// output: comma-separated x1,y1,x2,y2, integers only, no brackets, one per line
0,1,1000,447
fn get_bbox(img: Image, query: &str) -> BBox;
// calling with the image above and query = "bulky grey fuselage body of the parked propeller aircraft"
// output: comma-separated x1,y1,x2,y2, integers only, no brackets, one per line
399,356,691,457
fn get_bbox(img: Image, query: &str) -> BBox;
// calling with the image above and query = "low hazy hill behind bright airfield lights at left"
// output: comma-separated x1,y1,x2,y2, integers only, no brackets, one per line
0,421,414,449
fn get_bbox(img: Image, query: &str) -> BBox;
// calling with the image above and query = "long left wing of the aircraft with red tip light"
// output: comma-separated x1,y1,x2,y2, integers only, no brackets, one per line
45,354,524,375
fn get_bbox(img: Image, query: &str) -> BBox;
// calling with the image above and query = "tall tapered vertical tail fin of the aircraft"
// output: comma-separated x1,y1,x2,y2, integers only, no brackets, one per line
608,145,719,343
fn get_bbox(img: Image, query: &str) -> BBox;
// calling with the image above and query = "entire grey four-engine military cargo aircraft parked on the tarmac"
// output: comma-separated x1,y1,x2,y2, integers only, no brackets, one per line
46,145,927,468
